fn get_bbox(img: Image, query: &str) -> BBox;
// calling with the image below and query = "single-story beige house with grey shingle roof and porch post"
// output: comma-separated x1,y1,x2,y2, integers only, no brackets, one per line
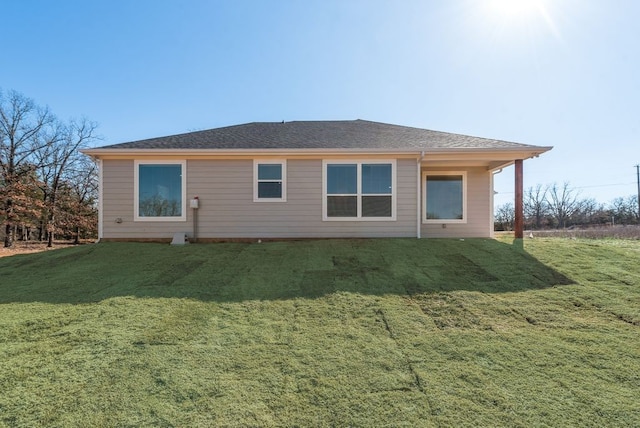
83,120,551,241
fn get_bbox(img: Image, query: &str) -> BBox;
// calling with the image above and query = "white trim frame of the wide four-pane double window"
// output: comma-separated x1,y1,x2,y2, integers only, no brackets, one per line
322,159,398,221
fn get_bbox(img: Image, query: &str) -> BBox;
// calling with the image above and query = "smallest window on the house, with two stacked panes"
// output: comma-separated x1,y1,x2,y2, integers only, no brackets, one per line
253,160,287,202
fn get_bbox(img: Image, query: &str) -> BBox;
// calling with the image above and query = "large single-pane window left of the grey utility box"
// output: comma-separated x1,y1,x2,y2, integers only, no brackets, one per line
134,161,187,221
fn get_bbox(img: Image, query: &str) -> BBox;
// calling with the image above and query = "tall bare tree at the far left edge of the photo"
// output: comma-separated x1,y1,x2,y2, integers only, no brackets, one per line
0,91,55,247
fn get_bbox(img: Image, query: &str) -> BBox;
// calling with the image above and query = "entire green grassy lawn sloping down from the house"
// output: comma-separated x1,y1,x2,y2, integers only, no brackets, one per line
0,238,640,427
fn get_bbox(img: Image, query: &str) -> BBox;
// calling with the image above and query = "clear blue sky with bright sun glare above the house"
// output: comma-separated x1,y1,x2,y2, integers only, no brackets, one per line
0,0,640,204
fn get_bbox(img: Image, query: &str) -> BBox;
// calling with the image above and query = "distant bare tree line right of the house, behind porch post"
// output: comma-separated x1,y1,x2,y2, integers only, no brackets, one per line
495,182,640,230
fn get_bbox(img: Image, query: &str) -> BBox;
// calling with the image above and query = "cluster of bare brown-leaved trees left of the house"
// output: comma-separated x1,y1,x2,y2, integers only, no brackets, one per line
0,90,98,247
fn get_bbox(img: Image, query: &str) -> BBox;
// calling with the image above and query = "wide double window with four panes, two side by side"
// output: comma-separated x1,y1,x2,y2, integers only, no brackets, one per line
323,161,396,220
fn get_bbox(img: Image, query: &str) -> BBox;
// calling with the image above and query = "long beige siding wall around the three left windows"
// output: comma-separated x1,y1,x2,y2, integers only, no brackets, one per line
103,159,417,239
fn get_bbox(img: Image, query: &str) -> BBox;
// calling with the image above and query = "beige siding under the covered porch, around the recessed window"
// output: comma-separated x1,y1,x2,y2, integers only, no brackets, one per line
421,167,493,238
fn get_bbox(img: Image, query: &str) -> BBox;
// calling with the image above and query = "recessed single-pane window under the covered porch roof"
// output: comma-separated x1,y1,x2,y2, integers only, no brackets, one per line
423,172,467,223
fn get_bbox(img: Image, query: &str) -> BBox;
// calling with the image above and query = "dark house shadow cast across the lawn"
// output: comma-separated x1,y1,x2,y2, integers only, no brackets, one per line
0,239,574,304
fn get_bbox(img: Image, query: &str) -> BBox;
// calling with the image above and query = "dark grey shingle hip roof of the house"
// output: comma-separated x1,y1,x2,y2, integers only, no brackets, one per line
100,120,540,151
